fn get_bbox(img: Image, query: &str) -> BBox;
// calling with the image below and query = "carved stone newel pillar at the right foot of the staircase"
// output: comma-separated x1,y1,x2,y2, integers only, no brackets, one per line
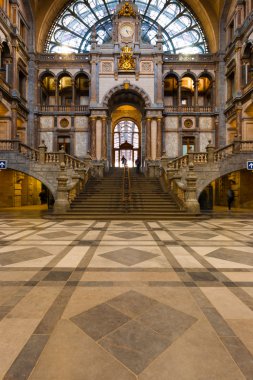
185,163,200,214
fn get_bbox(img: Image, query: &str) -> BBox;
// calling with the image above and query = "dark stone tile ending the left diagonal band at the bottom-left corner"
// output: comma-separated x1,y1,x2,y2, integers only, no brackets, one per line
4,335,48,380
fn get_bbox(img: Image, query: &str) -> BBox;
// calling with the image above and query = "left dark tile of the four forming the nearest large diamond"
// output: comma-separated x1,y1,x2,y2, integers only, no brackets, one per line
71,304,129,340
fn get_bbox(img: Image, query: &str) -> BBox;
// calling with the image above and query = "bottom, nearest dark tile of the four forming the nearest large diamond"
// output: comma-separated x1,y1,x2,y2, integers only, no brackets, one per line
99,321,168,375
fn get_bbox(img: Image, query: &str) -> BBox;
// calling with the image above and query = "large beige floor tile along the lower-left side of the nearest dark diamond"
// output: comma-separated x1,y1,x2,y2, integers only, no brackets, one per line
29,321,136,380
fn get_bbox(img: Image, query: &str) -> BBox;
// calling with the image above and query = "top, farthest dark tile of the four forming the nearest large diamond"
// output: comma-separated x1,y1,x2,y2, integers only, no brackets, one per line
107,290,158,318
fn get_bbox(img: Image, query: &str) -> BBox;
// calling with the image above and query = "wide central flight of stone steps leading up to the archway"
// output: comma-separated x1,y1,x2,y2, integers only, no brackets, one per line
64,168,200,220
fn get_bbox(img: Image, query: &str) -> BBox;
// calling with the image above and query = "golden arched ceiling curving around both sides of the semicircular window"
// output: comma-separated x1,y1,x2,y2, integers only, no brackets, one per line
30,0,225,52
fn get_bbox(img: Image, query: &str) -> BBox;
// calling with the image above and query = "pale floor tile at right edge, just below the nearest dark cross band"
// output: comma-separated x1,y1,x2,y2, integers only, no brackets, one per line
201,288,253,319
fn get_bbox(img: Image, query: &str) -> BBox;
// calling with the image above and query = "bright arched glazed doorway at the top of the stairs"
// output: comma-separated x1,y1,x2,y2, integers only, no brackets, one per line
113,120,140,167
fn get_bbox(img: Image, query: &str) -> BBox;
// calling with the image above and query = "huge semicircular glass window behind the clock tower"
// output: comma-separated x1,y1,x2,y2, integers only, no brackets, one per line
45,0,208,54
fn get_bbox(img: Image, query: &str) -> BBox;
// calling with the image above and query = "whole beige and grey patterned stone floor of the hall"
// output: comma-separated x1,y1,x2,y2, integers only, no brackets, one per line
0,218,253,380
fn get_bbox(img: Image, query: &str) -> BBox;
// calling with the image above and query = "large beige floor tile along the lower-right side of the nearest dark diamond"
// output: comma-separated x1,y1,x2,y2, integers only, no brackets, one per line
139,321,245,380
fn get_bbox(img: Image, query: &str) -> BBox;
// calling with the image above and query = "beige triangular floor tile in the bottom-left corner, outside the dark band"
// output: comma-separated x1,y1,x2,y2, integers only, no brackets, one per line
0,318,39,379
